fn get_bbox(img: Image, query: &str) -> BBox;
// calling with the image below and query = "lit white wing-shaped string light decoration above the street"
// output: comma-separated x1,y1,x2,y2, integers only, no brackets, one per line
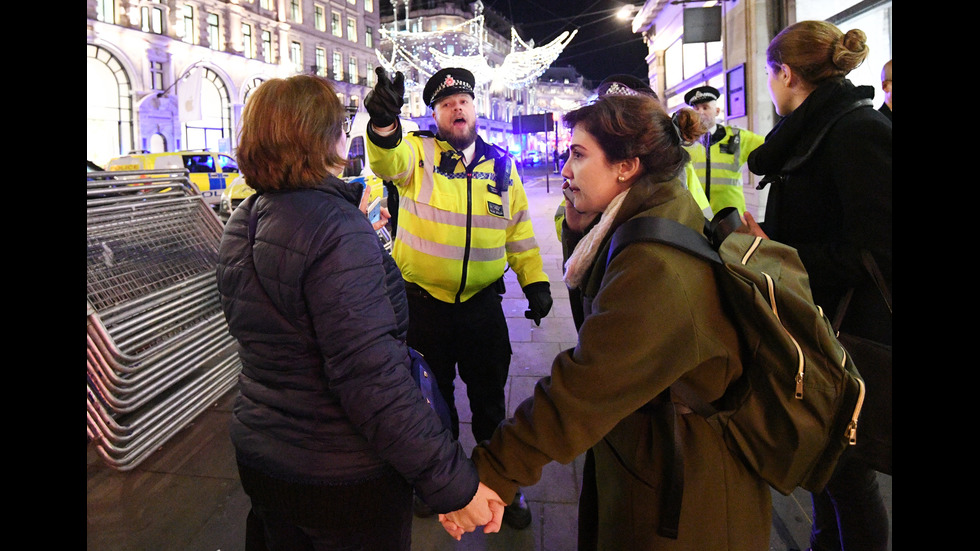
375,0,578,91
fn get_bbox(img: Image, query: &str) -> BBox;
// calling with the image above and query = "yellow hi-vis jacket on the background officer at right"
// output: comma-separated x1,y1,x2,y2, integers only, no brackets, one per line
687,125,765,213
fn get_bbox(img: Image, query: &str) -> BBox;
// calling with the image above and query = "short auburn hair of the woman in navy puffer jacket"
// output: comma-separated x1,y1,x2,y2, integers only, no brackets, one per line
235,75,347,191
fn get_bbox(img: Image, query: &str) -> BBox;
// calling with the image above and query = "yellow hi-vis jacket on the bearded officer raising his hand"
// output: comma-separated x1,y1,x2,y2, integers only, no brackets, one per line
367,129,548,303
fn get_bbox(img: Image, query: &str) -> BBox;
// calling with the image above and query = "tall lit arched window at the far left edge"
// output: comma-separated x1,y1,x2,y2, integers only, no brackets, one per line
86,44,133,166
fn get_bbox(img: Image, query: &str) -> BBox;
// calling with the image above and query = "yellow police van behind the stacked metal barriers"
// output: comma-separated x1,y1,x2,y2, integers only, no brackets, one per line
106,150,241,208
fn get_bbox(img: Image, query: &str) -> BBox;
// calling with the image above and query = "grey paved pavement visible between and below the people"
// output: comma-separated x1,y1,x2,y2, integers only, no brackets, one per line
86,167,892,551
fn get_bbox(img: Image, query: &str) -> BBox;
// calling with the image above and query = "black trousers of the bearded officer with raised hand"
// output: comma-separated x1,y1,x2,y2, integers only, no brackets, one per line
405,284,511,442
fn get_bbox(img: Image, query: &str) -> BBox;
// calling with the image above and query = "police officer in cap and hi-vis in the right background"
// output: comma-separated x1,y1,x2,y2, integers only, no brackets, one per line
684,86,765,213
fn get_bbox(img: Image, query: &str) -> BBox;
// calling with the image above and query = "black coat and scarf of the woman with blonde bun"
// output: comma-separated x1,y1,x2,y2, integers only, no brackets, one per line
748,79,892,343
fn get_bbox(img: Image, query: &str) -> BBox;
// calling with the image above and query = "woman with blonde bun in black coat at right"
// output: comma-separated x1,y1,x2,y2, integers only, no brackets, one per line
745,21,892,551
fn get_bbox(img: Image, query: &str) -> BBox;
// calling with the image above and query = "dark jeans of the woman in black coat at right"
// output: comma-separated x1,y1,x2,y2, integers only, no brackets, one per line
810,450,888,551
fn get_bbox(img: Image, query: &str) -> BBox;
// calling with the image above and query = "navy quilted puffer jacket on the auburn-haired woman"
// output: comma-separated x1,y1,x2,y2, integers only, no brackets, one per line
217,177,479,512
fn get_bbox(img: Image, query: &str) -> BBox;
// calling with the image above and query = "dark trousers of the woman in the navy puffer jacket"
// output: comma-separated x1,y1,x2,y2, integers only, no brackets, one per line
239,465,412,551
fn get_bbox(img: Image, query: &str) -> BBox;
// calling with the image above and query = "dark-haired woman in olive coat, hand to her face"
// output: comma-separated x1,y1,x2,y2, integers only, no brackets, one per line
442,96,772,551
